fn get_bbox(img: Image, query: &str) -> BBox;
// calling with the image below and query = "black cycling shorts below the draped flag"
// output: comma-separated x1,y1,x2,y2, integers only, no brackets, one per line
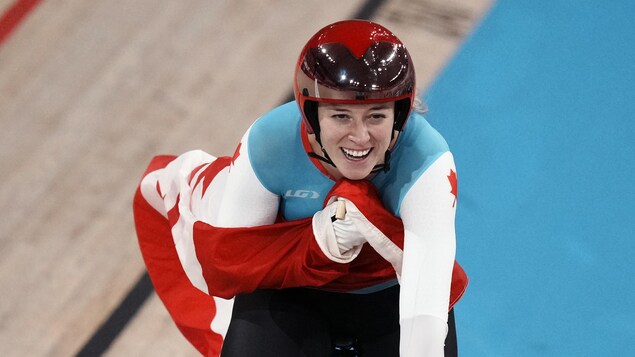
221,285,457,357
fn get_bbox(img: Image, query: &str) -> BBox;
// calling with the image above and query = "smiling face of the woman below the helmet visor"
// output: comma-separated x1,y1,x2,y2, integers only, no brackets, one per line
310,102,396,180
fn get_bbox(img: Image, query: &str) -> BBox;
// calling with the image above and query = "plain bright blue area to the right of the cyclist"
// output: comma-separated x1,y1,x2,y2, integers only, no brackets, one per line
424,0,635,357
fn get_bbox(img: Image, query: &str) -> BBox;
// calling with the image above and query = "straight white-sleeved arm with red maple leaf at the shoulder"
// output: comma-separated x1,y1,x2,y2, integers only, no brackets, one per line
400,152,456,356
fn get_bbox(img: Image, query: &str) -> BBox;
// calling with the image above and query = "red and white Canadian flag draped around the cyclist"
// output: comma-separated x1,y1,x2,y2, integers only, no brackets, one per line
133,155,467,356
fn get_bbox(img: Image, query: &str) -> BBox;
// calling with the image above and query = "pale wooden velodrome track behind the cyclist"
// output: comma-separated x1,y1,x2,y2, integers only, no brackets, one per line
0,0,491,356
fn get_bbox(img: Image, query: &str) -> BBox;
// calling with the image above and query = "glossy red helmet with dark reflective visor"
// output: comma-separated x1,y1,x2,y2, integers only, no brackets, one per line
293,20,415,137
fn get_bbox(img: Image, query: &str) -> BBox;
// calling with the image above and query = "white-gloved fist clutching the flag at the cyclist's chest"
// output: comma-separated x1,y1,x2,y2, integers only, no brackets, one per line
313,198,366,263
